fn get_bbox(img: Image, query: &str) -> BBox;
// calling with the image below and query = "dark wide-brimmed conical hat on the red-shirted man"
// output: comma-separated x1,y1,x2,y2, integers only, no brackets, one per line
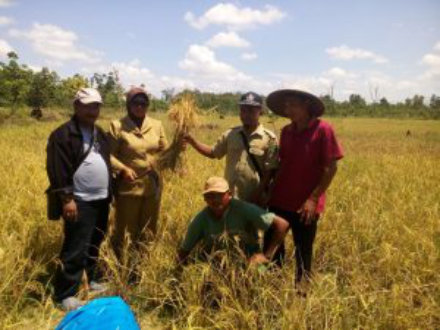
266,89,325,117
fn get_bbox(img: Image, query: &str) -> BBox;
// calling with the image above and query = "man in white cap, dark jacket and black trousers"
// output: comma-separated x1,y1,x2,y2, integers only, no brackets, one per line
46,88,111,310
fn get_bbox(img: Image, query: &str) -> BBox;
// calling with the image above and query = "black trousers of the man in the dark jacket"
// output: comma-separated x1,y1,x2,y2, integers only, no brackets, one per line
54,199,109,301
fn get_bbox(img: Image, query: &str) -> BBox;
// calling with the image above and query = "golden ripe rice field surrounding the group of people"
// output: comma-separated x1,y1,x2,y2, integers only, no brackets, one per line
0,110,440,329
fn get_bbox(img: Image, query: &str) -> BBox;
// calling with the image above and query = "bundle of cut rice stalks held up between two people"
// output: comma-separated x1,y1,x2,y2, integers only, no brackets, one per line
159,94,199,173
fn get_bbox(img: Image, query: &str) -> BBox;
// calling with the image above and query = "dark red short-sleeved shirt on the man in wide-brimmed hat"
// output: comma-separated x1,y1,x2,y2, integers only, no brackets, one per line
269,119,343,213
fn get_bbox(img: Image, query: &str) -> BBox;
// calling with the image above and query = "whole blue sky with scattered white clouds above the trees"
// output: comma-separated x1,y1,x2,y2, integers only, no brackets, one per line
0,0,440,102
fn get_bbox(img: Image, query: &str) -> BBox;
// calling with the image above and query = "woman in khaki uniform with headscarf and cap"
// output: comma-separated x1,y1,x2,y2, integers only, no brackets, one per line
109,87,167,258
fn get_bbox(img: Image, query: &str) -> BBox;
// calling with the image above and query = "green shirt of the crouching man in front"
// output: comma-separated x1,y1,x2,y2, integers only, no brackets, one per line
181,198,275,256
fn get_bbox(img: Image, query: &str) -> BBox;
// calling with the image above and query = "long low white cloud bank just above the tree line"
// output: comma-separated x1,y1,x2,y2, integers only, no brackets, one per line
78,53,438,102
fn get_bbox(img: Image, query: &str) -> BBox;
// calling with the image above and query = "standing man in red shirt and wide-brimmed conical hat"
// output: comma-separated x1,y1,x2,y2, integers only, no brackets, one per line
263,89,343,283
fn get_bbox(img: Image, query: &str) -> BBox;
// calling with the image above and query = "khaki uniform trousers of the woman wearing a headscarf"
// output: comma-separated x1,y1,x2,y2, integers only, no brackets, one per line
112,195,160,258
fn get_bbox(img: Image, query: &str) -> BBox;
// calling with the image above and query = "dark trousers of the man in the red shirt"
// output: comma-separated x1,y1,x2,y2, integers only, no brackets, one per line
263,208,319,282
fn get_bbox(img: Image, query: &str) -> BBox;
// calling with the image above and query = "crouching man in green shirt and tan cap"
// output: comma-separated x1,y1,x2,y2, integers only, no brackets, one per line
178,177,289,264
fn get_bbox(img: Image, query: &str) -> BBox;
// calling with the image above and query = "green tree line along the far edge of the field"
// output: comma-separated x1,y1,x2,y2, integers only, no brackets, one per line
0,52,440,119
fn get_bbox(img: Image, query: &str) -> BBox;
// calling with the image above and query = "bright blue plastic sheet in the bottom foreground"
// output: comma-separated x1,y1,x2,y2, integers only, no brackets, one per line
56,297,140,330
